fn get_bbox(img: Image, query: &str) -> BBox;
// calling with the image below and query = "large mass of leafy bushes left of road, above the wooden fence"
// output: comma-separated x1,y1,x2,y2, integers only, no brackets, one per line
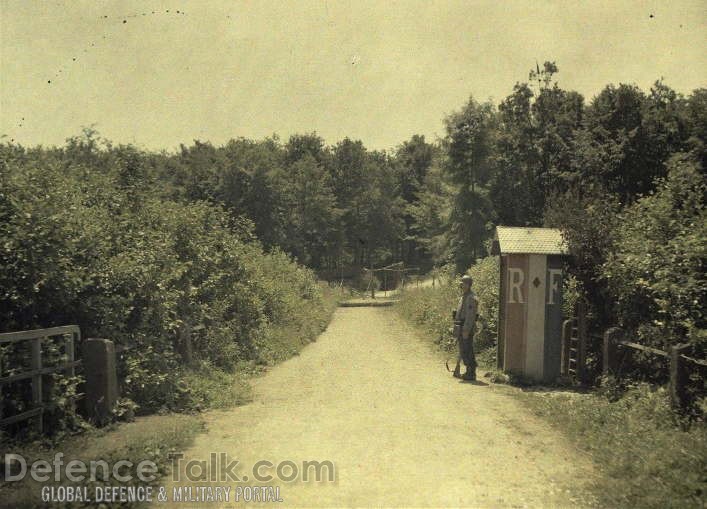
0,143,332,428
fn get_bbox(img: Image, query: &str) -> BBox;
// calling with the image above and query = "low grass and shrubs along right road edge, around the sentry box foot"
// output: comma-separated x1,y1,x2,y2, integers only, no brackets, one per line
396,278,707,509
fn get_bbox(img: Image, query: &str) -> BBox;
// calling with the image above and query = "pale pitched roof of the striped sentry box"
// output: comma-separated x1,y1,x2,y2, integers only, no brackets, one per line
491,226,569,255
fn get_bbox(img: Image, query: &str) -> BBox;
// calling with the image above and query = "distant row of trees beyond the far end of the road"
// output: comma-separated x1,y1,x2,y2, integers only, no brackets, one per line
154,133,440,271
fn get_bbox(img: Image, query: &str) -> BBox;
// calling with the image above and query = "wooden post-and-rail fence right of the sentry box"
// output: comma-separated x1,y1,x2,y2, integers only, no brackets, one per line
602,327,707,409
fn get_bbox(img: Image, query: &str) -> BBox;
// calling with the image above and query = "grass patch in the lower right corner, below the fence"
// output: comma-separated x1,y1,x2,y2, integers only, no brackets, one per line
515,385,707,509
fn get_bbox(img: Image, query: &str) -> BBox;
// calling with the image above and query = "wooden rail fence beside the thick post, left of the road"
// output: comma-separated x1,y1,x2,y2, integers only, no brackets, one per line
0,325,81,433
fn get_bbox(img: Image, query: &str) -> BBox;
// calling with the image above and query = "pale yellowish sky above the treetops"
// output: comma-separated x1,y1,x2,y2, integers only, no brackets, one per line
0,0,707,151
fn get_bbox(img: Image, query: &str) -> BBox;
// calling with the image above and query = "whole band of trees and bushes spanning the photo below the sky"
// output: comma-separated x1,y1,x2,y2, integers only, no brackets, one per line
0,62,707,428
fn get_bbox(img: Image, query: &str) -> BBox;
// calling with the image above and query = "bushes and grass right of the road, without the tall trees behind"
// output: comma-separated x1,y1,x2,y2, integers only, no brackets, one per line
399,134,707,508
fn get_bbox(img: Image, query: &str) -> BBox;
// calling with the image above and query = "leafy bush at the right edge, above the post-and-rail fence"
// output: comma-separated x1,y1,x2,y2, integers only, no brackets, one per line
603,154,707,357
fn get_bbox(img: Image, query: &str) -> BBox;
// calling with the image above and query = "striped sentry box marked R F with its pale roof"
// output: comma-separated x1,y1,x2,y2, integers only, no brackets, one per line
491,226,568,382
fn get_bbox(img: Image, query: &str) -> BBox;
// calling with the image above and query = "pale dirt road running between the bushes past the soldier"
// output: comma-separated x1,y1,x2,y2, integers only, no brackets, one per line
162,308,595,507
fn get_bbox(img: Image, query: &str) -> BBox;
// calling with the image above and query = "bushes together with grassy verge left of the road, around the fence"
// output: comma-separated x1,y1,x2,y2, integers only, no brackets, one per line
0,137,336,507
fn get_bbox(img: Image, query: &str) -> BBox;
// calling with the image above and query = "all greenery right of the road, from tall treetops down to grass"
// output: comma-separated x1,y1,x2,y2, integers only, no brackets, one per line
399,62,707,508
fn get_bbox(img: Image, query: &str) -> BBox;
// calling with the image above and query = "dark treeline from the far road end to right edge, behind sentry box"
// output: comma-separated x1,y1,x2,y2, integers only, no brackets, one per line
133,62,707,354
